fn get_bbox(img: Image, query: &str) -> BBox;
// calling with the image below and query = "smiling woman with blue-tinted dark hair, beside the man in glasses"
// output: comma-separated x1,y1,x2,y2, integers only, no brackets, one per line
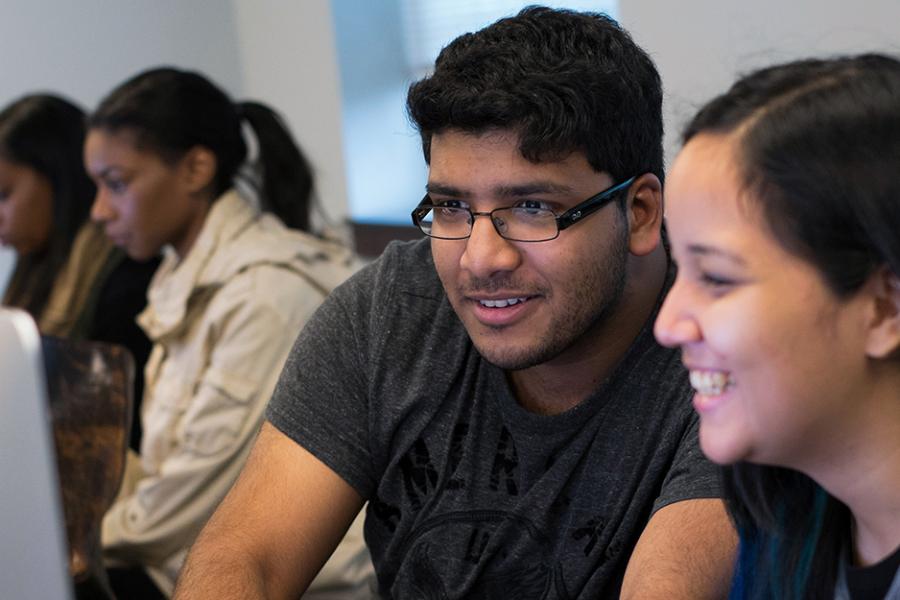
656,54,900,600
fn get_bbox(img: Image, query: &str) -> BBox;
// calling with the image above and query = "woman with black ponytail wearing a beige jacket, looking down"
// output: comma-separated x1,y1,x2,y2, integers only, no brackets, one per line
84,68,370,598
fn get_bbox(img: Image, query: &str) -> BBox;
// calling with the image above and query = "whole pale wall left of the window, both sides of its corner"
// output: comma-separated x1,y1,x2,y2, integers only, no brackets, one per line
0,0,347,290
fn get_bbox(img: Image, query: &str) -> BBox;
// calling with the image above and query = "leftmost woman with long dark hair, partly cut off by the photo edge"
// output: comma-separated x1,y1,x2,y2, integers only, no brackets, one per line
0,94,159,449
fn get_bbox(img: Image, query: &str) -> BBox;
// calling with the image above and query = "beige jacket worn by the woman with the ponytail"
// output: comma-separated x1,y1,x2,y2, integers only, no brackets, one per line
102,191,371,594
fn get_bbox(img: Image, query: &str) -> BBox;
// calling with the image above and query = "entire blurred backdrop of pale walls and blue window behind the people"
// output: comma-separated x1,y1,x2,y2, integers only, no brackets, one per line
0,0,900,290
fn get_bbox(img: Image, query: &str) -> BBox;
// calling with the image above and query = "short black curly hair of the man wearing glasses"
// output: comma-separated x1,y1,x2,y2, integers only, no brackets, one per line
407,6,663,181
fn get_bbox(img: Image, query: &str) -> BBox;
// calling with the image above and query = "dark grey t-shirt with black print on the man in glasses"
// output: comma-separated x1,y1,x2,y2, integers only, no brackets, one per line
267,240,719,599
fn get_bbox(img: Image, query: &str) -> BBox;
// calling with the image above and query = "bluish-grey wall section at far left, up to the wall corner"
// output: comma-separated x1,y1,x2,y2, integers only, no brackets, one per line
0,0,240,108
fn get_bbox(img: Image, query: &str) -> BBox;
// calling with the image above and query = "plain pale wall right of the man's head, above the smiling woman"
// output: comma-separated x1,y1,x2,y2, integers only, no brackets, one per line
619,0,900,162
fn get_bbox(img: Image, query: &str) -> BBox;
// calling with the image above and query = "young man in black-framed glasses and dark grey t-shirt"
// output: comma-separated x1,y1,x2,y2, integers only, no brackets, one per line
177,8,734,599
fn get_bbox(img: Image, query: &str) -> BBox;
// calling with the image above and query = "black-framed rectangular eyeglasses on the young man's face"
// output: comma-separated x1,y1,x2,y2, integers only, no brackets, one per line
411,177,636,242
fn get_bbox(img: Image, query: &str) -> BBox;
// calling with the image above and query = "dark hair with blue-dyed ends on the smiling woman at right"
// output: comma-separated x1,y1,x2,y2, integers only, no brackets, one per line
684,54,900,599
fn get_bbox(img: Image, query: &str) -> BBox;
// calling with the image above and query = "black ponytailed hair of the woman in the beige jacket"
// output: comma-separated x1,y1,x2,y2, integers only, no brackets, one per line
88,67,313,231
